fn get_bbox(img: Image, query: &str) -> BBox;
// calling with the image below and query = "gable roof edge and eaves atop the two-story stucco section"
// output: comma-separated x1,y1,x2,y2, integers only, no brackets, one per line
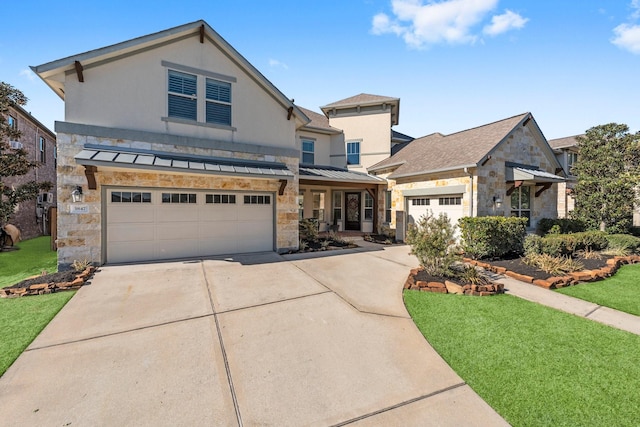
31,20,309,124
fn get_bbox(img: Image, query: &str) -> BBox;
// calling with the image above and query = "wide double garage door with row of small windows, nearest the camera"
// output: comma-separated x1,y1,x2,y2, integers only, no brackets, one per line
106,189,274,262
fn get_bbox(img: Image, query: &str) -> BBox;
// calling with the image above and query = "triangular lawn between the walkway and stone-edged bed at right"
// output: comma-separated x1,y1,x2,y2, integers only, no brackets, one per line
556,264,640,316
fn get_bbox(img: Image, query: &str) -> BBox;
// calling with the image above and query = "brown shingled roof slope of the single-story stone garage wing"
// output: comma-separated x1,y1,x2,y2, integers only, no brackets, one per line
368,113,537,178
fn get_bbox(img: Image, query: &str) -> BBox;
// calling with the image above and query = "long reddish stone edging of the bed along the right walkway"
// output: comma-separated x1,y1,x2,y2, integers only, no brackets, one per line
464,255,640,289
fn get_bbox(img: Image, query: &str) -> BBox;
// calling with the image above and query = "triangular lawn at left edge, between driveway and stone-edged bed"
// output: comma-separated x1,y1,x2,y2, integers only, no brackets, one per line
0,292,75,376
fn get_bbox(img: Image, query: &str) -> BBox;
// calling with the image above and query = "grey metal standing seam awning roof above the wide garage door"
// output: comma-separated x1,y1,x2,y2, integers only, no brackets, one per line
75,147,294,179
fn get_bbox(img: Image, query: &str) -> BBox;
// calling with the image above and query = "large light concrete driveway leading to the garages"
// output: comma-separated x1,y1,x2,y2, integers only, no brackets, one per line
0,246,507,426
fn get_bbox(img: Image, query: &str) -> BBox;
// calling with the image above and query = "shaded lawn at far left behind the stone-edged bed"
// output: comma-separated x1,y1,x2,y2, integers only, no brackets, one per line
0,236,58,288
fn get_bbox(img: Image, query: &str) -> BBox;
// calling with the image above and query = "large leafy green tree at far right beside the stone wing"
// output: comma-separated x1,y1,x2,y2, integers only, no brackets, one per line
572,123,640,233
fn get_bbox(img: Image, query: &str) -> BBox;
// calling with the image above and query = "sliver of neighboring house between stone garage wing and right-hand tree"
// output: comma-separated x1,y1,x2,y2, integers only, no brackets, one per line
549,135,584,218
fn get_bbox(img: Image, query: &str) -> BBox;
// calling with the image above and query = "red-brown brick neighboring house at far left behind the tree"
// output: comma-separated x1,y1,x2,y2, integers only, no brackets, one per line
4,105,56,239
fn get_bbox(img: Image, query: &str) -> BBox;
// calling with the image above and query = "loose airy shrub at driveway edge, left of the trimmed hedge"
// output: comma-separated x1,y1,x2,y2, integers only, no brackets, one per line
406,213,461,277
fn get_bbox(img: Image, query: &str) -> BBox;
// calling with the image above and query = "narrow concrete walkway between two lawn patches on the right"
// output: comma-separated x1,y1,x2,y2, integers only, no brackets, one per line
497,276,640,335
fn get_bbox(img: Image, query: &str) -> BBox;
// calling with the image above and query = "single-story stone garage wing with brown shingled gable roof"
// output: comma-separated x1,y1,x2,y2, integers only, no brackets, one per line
368,113,565,239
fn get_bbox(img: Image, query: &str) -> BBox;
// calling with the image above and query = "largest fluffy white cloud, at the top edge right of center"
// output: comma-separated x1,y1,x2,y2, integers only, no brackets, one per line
371,0,527,48
